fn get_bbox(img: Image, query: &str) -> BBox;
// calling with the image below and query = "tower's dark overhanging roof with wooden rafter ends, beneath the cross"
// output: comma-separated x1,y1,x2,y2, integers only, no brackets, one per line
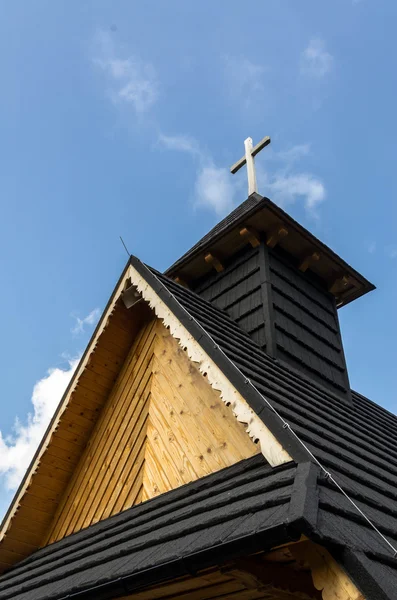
165,193,375,307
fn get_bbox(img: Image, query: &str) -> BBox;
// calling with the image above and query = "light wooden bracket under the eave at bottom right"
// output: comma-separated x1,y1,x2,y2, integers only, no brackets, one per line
291,541,365,600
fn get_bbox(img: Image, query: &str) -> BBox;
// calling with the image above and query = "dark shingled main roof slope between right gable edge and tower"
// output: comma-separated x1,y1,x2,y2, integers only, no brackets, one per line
133,259,397,598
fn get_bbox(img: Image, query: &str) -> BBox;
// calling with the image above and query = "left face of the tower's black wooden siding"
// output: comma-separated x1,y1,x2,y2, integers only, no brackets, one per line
194,247,266,350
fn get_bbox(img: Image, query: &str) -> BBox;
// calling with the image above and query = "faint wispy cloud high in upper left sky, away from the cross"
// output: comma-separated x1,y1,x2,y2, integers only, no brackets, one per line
93,31,158,114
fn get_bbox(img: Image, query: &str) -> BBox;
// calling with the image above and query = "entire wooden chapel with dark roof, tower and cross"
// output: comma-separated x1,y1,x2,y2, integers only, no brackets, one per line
0,138,397,600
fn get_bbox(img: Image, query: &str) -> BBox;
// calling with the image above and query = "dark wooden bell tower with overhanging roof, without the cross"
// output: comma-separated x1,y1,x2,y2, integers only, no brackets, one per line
166,193,374,402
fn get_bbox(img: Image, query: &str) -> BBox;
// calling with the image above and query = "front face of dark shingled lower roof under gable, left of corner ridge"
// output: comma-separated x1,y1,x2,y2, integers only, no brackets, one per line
0,455,298,600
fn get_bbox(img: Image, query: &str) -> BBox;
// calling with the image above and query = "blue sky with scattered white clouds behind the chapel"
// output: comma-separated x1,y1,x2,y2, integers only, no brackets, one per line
0,0,397,514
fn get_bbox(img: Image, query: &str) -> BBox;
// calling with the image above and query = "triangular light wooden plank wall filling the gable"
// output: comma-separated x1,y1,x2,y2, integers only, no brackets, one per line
47,319,259,543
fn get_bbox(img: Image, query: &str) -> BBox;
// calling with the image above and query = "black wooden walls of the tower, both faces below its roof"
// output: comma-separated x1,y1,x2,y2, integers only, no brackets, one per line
192,242,350,396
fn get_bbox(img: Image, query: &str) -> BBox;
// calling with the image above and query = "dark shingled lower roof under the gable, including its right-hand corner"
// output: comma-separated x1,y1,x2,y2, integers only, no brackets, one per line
0,455,397,600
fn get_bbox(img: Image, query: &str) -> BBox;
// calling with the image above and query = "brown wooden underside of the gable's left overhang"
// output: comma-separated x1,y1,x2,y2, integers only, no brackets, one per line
0,300,151,570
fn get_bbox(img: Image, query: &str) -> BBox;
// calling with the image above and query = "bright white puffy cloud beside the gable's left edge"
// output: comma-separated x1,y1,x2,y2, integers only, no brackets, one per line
0,358,79,490
